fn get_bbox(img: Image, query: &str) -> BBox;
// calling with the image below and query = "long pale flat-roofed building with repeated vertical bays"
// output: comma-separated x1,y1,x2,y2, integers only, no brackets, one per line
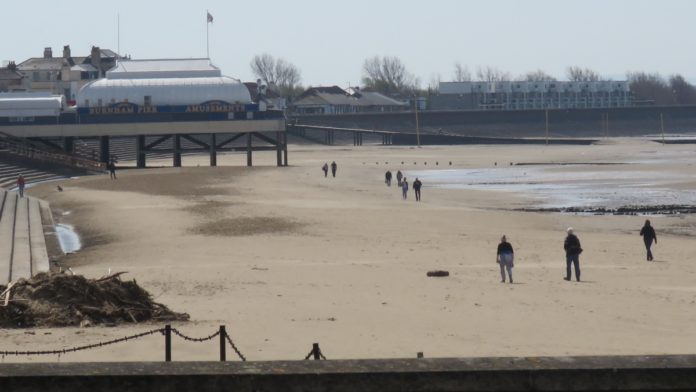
431,81,632,110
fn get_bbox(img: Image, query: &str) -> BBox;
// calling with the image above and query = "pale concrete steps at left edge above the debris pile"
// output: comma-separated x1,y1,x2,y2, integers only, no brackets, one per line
0,190,50,285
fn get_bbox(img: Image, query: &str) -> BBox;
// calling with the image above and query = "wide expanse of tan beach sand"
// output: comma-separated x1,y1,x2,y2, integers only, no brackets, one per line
0,139,696,361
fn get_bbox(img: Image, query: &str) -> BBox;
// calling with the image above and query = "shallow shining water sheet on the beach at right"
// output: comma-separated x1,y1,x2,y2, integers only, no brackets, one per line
405,165,696,209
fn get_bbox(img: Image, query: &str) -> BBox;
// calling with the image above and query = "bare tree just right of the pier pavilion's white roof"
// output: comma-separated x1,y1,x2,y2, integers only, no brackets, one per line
250,53,302,97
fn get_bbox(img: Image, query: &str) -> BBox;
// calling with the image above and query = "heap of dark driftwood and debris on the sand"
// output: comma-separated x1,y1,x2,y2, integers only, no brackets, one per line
0,272,189,328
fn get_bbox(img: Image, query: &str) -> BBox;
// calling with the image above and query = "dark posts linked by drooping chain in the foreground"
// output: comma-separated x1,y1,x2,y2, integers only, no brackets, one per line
0,324,326,362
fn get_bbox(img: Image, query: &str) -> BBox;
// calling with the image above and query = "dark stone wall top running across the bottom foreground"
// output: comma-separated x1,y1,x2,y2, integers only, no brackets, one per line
0,355,696,392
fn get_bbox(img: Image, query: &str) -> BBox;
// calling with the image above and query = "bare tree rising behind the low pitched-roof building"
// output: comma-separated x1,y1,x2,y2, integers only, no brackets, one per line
362,56,418,95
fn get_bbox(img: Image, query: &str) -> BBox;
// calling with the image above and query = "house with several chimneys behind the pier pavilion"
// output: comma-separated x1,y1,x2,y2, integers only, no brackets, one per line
17,45,121,101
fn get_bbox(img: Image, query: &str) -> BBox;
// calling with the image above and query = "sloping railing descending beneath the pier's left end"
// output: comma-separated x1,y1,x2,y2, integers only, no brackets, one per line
0,132,106,171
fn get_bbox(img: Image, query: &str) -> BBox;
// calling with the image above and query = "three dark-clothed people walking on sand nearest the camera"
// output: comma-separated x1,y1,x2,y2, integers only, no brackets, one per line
495,219,657,283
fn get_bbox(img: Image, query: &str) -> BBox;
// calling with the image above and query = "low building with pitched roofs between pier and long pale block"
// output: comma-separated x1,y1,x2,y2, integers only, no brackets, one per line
290,86,409,114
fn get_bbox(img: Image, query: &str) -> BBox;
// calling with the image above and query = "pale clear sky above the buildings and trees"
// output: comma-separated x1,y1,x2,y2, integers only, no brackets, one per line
0,0,696,87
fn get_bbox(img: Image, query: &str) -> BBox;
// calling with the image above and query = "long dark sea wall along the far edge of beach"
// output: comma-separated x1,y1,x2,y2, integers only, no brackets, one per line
289,105,696,137
